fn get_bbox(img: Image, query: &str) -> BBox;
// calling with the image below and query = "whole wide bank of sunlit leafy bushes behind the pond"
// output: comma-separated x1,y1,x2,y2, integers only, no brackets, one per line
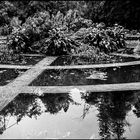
8,10,125,55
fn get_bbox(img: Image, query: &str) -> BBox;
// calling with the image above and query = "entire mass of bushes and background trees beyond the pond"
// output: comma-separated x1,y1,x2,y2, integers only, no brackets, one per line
0,0,139,56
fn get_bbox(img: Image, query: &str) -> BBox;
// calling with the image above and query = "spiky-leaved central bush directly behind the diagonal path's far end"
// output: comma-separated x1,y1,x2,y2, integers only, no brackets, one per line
31,28,78,55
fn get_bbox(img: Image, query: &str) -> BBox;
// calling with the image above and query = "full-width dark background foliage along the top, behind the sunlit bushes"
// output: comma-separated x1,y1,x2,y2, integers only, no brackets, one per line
0,0,140,29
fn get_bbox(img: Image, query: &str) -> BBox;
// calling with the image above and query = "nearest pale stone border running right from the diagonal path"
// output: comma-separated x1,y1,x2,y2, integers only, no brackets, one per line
21,82,140,93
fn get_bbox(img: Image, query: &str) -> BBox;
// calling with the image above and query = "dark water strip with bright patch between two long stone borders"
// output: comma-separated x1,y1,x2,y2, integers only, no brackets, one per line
30,65,140,86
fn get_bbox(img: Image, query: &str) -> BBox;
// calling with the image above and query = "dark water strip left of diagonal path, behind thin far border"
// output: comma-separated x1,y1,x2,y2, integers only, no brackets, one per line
0,56,44,65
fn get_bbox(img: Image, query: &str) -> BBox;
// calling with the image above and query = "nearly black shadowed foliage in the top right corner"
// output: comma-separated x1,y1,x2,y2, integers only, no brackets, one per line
96,0,140,29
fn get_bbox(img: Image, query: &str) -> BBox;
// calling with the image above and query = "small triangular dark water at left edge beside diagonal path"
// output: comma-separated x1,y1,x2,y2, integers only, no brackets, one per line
0,68,26,86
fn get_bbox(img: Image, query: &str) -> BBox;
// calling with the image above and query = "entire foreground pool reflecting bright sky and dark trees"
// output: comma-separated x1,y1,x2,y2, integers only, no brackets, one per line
0,90,140,139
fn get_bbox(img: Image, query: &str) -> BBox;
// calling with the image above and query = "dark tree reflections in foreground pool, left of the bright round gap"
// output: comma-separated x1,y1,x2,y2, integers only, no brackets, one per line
0,93,76,134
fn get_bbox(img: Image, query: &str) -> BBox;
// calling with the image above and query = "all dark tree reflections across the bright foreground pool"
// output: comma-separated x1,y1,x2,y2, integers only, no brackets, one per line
0,91,140,139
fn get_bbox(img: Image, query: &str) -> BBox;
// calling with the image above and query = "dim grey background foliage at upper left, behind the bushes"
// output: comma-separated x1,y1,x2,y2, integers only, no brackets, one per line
0,0,85,25
